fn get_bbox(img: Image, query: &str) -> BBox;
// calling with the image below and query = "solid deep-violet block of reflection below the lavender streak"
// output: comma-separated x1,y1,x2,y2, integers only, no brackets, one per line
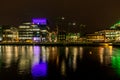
31,63,47,77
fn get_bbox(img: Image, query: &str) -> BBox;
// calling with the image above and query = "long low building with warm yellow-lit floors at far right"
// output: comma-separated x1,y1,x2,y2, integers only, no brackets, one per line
87,30,120,42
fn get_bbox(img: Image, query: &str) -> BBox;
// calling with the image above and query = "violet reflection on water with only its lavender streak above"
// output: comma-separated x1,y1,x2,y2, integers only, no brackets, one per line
31,46,47,78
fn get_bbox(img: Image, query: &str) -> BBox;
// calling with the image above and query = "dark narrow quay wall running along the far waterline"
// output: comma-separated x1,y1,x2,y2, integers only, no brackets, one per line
0,42,115,46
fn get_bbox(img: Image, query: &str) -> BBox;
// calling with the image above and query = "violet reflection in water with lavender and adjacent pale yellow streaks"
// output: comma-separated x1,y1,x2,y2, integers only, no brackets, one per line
31,46,47,78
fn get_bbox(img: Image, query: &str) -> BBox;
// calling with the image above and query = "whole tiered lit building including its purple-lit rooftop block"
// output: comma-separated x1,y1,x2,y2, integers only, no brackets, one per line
19,18,49,42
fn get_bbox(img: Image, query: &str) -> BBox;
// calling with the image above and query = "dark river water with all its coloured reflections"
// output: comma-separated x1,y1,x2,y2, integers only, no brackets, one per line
0,46,120,80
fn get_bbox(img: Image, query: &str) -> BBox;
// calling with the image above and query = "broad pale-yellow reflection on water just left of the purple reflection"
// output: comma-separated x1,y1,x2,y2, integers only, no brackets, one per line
18,46,33,74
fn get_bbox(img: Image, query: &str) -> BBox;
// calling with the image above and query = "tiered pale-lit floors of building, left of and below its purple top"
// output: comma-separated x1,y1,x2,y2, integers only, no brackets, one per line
19,23,41,41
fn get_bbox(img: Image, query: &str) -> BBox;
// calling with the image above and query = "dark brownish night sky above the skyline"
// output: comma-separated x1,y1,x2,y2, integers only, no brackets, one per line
0,0,120,32
